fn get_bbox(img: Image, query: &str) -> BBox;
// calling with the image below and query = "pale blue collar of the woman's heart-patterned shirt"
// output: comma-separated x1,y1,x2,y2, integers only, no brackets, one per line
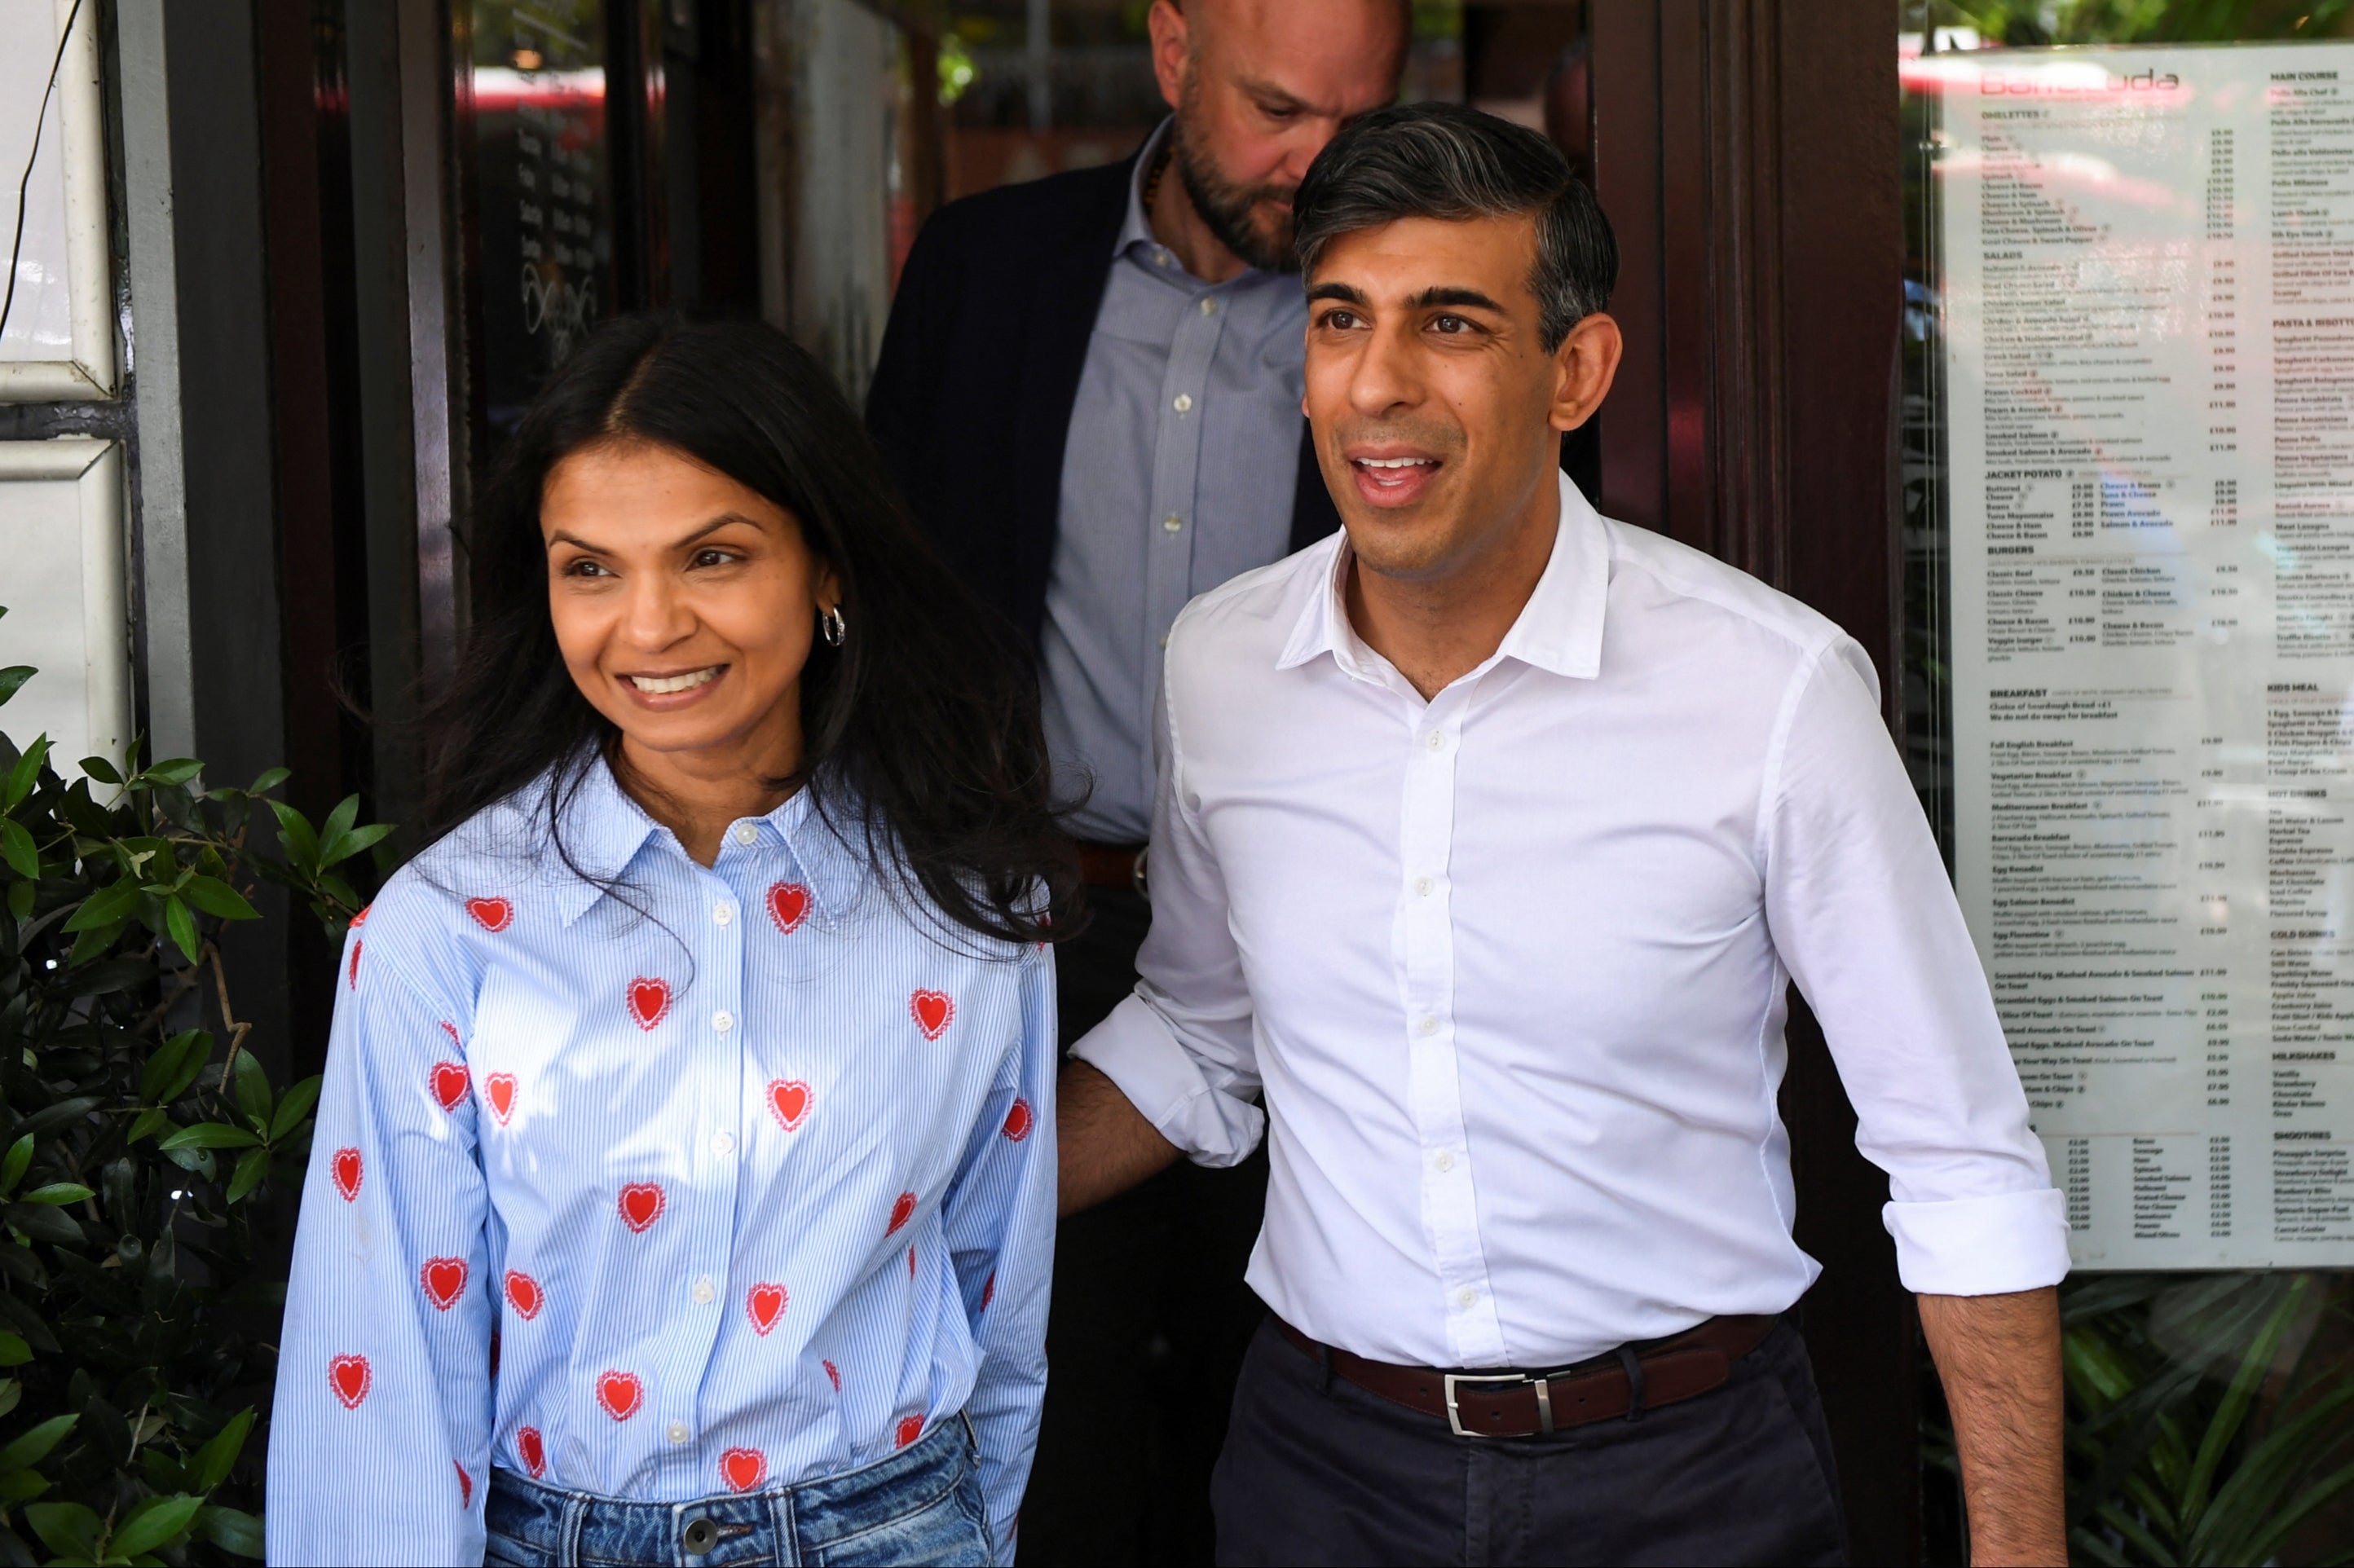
549,755,866,925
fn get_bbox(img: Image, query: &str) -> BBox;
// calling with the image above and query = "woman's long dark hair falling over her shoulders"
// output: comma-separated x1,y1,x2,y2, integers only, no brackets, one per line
424,315,1078,942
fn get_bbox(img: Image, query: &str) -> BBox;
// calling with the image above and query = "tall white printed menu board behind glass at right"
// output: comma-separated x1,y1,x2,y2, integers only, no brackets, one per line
1937,45,2354,1269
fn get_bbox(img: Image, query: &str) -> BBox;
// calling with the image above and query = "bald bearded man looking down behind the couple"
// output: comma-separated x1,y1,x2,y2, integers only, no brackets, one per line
866,0,1410,1563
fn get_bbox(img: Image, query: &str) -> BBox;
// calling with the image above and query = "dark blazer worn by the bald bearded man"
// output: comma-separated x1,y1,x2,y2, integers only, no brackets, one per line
866,158,1339,643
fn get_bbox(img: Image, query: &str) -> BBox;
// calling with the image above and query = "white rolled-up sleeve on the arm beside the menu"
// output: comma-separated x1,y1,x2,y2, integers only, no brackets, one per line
1761,638,2070,1295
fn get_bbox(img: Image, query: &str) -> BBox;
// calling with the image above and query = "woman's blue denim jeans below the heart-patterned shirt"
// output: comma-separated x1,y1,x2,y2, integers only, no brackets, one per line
483,1417,989,1568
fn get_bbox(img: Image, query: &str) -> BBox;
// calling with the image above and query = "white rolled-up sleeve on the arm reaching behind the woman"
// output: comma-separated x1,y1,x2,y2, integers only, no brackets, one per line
1071,658,1267,1165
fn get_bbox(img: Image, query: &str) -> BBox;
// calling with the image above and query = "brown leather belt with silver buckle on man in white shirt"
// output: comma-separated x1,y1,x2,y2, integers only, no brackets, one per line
1276,1319,1779,1436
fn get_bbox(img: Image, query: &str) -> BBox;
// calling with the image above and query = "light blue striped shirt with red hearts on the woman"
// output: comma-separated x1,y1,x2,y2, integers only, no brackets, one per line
268,763,1055,1563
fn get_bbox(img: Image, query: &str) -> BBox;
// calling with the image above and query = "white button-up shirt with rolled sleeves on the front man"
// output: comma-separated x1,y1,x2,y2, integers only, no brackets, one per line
1076,480,2067,1368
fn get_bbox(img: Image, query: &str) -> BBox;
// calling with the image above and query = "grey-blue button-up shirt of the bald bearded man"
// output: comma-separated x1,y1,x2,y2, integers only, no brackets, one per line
1038,120,1307,843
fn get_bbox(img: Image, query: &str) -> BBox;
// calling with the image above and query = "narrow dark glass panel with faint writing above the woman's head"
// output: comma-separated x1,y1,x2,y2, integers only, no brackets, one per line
471,0,615,445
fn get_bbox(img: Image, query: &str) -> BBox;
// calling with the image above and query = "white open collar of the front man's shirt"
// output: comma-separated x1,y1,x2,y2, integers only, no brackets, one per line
1276,473,1610,680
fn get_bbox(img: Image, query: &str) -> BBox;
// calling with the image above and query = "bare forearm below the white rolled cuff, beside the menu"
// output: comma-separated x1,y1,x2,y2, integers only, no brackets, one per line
1920,1280,2067,1568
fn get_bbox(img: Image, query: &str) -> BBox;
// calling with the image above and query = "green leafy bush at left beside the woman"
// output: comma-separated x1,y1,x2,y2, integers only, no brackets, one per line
0,610,389,1563
